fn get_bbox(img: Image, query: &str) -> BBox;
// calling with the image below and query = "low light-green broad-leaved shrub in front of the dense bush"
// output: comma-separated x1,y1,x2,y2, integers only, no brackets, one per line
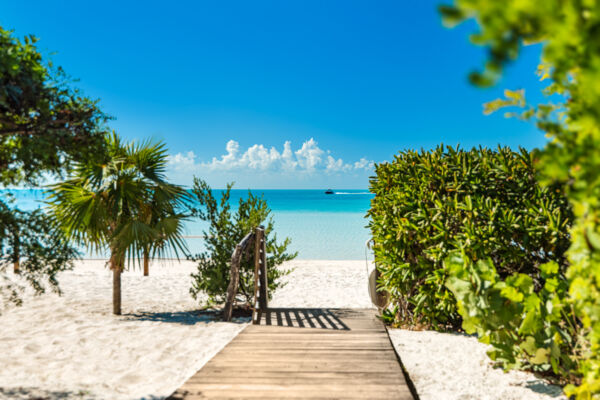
445,251,581,384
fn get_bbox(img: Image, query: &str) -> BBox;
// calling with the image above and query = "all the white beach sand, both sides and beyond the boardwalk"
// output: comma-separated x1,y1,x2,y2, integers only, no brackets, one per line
0,260,560,400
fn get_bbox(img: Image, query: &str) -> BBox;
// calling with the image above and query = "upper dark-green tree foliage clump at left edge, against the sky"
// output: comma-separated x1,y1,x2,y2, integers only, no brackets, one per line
0,28,107,185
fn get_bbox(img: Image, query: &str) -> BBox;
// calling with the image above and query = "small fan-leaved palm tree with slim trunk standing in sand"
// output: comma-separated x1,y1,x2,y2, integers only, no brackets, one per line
49,132,187,315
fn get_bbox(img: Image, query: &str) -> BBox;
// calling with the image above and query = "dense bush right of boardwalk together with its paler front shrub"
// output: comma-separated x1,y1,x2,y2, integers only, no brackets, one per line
369,146,585,385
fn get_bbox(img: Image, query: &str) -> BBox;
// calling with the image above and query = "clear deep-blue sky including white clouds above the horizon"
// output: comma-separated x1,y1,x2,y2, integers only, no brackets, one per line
0,0,545,188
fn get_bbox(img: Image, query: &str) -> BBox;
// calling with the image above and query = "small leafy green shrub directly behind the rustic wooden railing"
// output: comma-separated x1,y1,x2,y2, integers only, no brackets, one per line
190,178,297,305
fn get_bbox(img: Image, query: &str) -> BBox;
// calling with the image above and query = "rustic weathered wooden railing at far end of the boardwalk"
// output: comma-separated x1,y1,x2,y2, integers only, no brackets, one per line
223,226,268,324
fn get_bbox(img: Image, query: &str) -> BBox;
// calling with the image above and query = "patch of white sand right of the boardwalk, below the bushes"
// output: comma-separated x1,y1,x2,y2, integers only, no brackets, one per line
389,329,566,400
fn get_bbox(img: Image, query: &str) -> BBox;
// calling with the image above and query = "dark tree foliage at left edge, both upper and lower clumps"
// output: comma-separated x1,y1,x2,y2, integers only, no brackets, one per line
0,27,108,302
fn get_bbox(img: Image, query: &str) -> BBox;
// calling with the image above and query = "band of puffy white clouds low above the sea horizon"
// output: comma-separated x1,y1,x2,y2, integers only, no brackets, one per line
169,138,373,174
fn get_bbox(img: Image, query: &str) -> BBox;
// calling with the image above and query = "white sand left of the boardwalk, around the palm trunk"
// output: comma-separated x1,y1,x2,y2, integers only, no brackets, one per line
0,261,245,400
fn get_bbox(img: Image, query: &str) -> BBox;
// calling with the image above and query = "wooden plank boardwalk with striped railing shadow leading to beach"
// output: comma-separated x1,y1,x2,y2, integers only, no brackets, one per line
169,309,413,400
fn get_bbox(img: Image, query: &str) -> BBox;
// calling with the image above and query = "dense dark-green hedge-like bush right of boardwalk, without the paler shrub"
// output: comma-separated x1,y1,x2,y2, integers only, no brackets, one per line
368,146,571,329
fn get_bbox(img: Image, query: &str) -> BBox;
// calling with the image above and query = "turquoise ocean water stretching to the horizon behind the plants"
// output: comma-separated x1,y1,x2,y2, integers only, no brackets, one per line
0,189,373,260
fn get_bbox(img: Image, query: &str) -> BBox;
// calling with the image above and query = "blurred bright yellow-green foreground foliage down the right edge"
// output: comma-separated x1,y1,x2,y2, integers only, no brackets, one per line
441,0,600,399
